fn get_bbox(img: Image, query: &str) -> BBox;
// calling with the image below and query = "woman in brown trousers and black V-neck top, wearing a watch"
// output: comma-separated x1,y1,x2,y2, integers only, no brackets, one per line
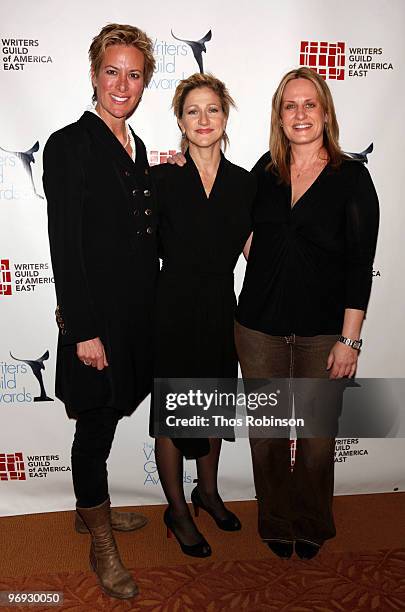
235,68,379,559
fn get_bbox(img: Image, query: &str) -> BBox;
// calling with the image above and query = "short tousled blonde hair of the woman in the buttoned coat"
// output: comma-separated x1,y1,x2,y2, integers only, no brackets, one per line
89,23,155,102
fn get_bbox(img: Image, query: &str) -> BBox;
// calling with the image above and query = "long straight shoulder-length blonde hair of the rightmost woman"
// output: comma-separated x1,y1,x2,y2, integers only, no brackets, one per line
268,67,344,184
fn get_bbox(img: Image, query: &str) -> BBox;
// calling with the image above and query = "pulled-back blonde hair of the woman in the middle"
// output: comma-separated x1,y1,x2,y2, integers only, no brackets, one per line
172,72,235,153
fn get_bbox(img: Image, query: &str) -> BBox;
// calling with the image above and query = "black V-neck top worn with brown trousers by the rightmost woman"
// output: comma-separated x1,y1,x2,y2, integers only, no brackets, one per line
236,153,379,336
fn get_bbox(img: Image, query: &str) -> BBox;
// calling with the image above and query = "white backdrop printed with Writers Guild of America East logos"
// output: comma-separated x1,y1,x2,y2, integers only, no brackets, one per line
0,0,405,515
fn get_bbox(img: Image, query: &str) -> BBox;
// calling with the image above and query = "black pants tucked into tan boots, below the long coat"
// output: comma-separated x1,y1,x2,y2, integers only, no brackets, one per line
72,408,121,508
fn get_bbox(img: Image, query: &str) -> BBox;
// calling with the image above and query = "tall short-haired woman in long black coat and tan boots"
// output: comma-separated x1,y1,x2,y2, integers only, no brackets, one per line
44,24,158,598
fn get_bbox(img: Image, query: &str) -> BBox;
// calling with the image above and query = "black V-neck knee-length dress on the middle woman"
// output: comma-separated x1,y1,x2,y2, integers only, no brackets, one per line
152,153,256,457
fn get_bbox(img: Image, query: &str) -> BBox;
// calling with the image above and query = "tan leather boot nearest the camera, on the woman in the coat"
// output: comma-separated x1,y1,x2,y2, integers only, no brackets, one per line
76,499,138,599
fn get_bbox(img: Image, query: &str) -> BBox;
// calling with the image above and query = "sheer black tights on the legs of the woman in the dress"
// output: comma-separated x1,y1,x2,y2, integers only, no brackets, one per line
155,438,228,545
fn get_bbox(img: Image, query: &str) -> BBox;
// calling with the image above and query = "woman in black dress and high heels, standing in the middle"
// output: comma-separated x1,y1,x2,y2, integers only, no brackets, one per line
153,74,255,557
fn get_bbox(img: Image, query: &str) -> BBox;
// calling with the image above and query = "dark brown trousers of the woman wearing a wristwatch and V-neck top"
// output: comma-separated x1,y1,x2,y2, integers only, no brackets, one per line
235,323,338,544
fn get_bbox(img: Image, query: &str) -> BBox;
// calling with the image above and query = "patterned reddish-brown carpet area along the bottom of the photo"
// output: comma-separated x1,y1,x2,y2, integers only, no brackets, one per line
0,548,405,612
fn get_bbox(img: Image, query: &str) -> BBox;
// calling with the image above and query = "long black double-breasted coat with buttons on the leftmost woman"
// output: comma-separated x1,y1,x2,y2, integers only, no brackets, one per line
43,112,158,414
